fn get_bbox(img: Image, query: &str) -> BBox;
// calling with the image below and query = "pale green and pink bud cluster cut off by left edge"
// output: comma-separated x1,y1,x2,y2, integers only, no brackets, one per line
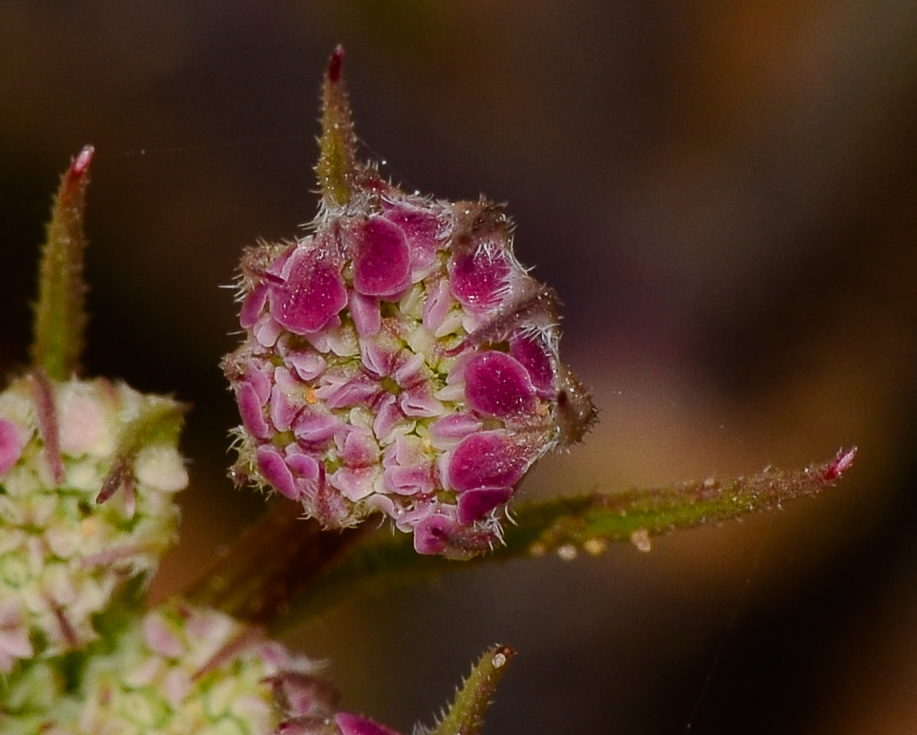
0,372,188,673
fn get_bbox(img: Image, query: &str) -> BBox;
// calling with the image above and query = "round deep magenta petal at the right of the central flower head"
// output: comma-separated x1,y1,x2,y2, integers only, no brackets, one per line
465,350,535,418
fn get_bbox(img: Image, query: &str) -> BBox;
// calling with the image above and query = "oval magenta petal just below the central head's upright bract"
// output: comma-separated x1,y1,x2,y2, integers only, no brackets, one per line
353,217,411,296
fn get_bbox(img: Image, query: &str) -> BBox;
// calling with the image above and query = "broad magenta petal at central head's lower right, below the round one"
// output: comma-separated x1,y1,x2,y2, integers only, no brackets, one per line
449,431,528,491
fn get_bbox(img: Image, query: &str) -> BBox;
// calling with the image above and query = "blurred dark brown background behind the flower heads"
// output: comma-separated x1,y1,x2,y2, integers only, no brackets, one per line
0,0,917,735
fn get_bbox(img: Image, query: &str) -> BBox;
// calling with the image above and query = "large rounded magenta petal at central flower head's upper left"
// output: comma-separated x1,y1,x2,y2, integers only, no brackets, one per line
270,247,347,334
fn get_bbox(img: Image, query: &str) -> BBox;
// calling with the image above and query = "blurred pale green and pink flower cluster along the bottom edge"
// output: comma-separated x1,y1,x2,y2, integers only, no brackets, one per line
0,600,310,735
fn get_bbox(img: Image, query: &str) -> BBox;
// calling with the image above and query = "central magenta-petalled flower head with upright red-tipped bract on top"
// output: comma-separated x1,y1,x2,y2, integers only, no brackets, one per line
223,46,594,557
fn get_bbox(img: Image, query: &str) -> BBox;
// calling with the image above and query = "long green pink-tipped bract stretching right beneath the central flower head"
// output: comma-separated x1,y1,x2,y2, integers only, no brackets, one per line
280,448,856,619
